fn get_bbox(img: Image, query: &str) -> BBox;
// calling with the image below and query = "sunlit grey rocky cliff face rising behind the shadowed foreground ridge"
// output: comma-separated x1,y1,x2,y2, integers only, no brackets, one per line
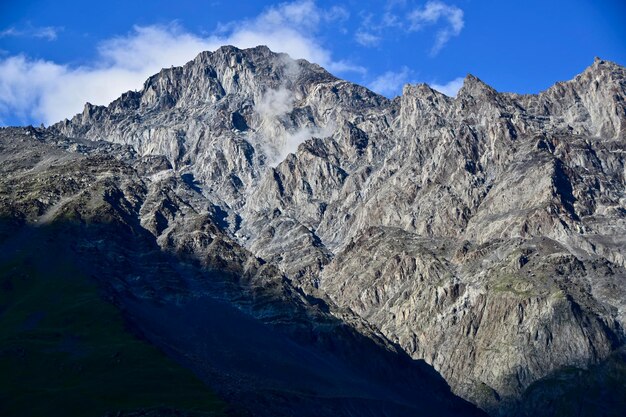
8,47,626,415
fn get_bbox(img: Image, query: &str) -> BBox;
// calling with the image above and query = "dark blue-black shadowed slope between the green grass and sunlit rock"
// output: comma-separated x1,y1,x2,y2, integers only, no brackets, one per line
0,216,482,416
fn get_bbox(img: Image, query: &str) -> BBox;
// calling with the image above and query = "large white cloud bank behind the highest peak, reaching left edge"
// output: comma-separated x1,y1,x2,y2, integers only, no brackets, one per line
0,1,365,124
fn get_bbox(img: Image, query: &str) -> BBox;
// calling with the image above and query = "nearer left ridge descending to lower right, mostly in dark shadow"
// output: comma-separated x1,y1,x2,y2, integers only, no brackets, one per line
0,128,483,417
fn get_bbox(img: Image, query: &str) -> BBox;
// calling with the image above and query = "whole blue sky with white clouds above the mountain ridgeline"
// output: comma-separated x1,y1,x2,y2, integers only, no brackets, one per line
0,0,626,125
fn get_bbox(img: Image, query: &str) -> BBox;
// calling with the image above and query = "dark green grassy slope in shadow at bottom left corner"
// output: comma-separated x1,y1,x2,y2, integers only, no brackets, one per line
0,231,226,417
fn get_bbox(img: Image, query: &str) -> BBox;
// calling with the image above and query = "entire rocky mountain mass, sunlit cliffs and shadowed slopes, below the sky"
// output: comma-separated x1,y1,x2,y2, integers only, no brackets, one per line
0,47,626,416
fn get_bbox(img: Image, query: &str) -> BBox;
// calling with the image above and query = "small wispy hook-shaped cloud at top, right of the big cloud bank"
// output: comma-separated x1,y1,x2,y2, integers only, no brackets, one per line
408,1,465,55
